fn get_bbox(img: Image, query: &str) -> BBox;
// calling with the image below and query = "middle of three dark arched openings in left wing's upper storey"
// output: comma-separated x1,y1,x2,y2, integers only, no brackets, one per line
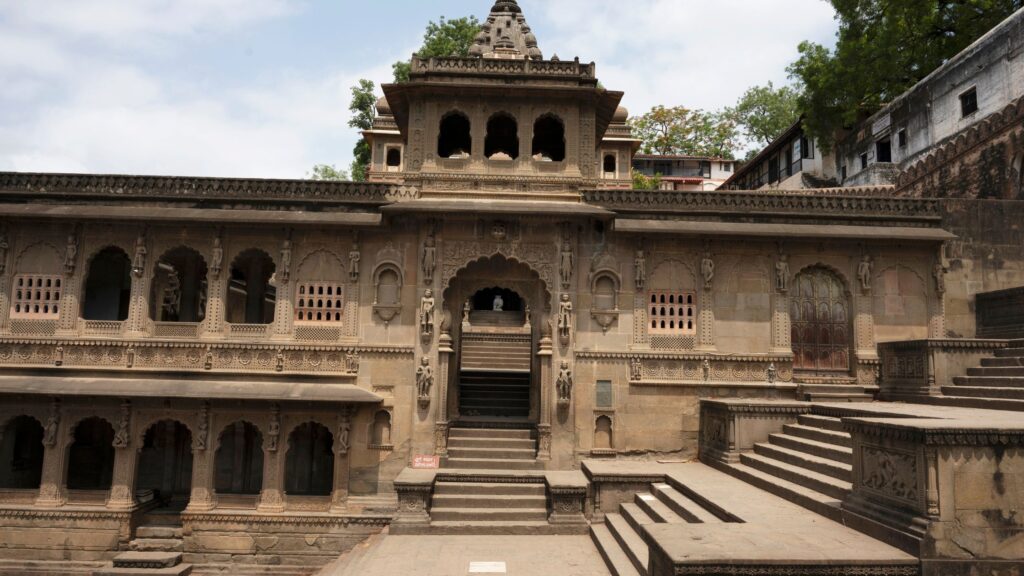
150,247,207,322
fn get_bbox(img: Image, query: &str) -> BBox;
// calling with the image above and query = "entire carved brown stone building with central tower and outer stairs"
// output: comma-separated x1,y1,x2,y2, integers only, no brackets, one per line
0,0,1024,575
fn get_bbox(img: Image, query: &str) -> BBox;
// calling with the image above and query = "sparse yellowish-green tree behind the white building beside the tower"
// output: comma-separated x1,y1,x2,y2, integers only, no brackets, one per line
631,106,737,159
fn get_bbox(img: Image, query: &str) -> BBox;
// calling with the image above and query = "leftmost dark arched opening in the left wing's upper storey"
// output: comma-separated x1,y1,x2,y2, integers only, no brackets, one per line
82,247,131,322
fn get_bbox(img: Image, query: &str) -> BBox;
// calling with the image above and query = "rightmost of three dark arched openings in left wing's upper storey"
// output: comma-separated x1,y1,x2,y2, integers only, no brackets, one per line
226,249,278,324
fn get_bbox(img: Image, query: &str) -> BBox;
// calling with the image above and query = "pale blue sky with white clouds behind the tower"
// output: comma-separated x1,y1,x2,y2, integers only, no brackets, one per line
0,0,837,178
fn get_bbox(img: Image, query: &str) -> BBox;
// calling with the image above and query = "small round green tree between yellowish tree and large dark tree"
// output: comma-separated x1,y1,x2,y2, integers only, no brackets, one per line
727,82,800,147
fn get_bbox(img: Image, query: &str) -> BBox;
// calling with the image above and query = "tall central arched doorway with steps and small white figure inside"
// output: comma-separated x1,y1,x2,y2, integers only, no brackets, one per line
444,255,551,422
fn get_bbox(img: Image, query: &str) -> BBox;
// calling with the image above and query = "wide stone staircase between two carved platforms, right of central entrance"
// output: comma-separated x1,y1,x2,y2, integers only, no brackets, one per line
708,414,853,522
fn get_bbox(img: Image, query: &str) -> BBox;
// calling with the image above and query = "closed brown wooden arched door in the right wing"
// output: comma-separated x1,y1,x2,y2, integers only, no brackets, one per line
791,266,850,374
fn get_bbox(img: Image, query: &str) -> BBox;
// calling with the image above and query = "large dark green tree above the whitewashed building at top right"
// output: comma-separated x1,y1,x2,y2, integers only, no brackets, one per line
788,0,1024,149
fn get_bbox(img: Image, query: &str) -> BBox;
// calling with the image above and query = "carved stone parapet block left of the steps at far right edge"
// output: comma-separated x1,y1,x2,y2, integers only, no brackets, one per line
879,339,1009,400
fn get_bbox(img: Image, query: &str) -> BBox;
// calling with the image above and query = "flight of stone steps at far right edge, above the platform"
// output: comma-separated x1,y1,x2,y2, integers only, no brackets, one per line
937,340,1024,411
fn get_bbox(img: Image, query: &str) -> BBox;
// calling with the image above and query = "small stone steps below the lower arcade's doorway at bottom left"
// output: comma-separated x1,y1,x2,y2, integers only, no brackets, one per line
93,525,193,576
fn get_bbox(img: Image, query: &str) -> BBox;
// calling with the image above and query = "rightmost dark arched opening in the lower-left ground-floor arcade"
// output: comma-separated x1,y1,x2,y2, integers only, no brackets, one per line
285,422,334,496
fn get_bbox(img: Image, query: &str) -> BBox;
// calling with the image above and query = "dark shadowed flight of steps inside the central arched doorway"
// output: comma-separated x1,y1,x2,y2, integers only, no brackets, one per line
459,372,529,418
